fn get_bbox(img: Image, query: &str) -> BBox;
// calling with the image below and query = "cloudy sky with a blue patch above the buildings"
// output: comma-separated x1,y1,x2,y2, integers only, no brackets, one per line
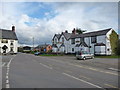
0,2,118,45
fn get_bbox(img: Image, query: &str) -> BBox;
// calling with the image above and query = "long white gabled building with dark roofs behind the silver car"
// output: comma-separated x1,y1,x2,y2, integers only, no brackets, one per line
52,28,118,55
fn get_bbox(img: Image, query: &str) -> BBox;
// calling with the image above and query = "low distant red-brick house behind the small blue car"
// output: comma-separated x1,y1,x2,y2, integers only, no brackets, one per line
34,44,52,52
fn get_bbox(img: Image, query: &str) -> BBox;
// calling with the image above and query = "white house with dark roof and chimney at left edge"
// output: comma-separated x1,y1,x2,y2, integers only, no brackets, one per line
0,26,18,53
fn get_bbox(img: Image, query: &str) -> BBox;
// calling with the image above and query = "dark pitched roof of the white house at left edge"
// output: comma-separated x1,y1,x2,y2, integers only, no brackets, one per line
0,29,18,40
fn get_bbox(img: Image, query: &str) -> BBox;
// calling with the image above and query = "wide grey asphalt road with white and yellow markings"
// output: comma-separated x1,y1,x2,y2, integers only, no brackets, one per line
2,53,119,89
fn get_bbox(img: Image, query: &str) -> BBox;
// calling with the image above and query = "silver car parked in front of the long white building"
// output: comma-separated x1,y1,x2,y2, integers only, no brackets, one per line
76,51,94,60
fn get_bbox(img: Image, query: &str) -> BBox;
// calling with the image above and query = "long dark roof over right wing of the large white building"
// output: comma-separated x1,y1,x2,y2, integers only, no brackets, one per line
70,28,112,38
